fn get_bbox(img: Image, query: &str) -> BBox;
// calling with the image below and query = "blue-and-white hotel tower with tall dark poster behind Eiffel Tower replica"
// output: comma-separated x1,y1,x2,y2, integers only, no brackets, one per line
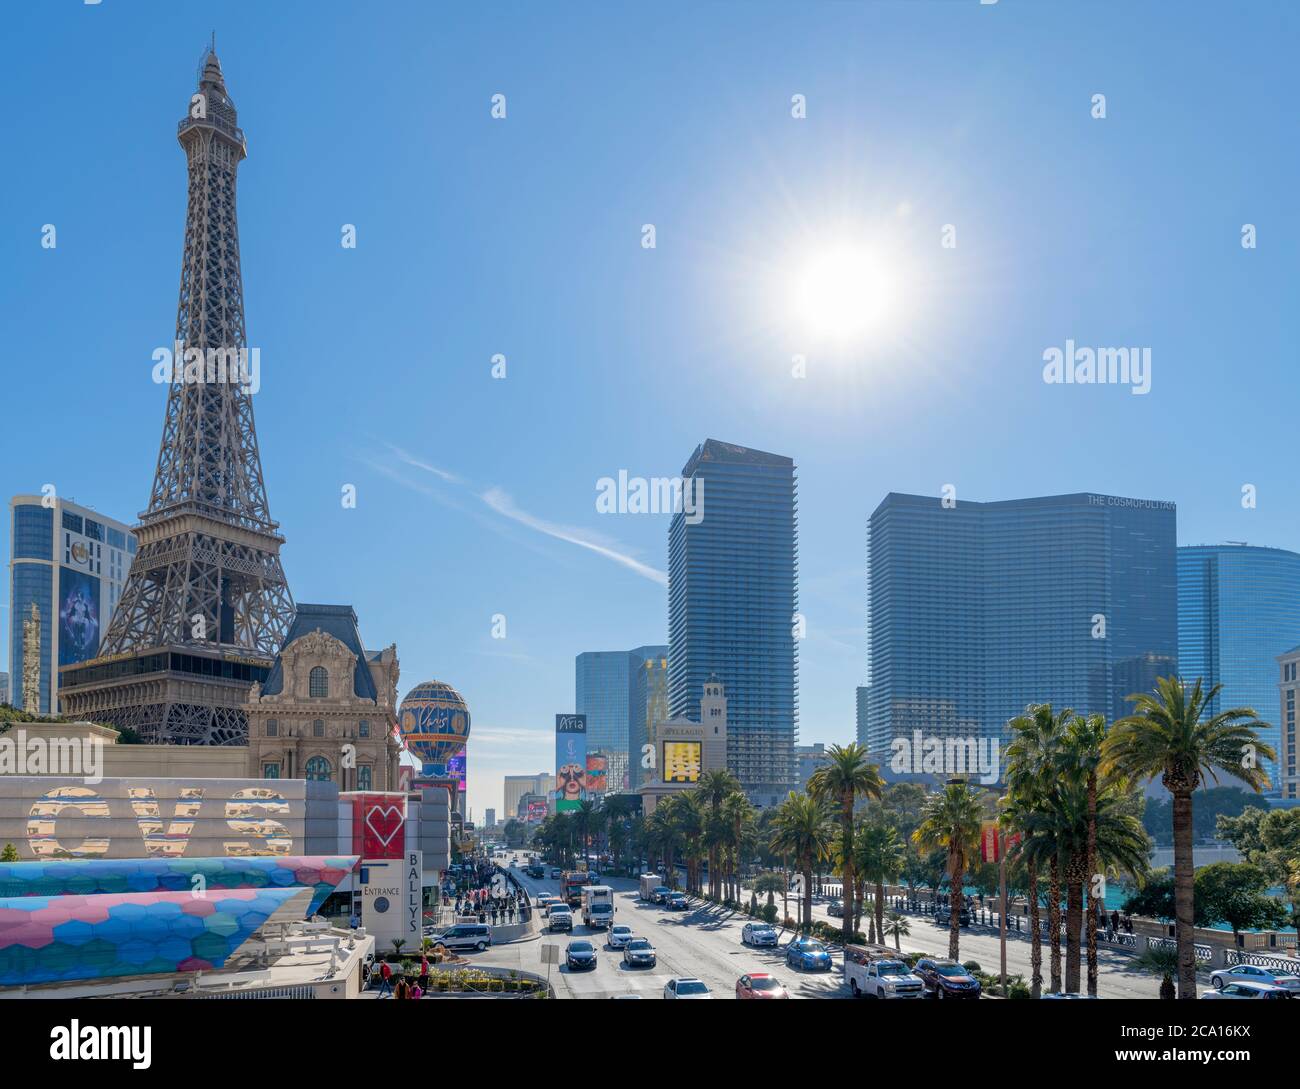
9,495,135,715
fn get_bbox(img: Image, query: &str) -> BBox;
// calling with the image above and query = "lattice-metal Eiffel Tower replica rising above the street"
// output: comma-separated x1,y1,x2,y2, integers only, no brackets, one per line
60,48,294,745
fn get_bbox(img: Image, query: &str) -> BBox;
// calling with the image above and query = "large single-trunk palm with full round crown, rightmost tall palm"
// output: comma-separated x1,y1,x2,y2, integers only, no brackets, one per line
1101,677,1277,998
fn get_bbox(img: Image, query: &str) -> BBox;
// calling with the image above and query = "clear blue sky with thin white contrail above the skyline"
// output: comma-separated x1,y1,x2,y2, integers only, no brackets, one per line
0,0,1300,815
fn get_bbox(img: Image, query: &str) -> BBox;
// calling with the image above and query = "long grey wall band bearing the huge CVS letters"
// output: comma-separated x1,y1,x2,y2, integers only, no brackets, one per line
0,776,314,859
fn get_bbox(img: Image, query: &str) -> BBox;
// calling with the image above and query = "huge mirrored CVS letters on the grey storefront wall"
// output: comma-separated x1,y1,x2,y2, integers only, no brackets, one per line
27,785,302,859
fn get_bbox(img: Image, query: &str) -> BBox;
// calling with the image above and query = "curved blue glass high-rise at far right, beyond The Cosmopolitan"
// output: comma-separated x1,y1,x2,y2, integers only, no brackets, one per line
1178,545,1300,795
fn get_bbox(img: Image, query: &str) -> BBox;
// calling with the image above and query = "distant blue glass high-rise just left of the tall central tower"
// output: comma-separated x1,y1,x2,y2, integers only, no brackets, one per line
573,646,668,793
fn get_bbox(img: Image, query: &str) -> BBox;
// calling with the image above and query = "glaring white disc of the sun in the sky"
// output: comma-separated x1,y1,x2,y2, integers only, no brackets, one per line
792,246,894,342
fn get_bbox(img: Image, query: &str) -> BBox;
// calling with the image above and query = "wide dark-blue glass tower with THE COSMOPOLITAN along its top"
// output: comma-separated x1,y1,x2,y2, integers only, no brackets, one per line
866,493,1178,756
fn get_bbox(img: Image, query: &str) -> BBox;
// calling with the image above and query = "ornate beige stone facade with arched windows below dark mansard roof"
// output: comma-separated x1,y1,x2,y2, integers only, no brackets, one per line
246,628,400,790
